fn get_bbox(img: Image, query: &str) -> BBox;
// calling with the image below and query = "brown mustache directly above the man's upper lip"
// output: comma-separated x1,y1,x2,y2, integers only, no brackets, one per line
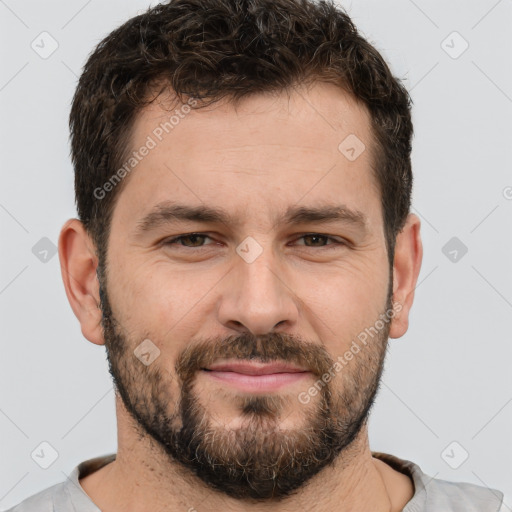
175,332,334,382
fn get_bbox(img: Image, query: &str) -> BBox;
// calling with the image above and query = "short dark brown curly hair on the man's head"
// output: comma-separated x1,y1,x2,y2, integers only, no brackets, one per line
69,0,413,272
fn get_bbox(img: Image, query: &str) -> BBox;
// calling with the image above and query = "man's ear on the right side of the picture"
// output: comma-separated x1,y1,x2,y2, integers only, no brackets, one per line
389,213,423,338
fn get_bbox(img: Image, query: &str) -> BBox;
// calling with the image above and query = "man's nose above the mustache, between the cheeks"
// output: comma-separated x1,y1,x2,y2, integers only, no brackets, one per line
217,241,298,336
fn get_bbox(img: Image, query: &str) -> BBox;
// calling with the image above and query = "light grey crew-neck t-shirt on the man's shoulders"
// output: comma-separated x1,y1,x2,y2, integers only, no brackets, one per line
7,452,503,512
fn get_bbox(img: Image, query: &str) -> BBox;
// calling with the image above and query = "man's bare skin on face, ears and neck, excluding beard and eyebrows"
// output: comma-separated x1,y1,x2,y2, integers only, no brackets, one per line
59,83,422,512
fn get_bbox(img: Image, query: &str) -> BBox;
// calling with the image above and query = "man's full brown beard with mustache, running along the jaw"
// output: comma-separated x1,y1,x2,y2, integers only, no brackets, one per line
100,268,392,501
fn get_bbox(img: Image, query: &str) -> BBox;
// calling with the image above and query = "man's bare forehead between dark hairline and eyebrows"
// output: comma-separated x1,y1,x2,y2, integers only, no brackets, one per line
114,83,379,230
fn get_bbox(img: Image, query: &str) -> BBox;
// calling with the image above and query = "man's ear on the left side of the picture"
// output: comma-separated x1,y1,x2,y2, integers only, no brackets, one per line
59,219,105,345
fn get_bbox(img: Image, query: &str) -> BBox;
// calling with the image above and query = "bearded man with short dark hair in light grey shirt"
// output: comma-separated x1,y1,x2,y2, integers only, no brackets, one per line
8,0,501,512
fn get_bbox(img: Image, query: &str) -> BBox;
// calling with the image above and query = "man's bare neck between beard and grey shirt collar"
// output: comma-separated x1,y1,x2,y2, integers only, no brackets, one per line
80,396,412,512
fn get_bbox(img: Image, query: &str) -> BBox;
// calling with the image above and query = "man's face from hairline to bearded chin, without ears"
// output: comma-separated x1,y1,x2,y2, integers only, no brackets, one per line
102,84,391,499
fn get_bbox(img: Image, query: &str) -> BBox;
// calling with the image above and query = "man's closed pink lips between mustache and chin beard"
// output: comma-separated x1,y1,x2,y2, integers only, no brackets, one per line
202,361,311,393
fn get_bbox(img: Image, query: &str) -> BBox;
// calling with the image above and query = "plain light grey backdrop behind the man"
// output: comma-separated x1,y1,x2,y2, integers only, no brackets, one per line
0,0,512,510
